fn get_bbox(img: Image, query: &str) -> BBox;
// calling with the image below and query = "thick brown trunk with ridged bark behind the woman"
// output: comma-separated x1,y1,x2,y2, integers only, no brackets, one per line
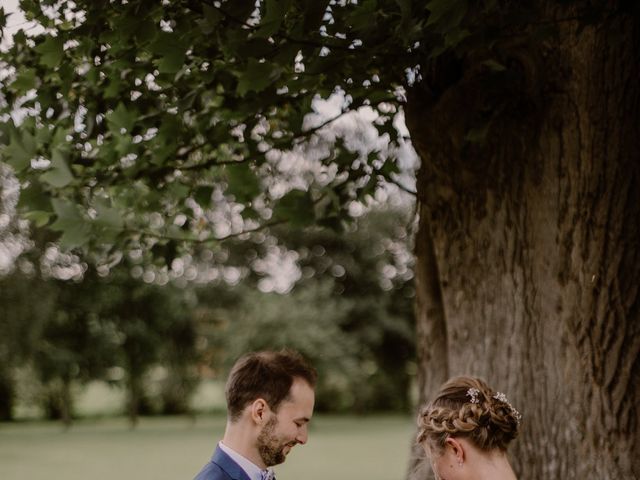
406,2,640,480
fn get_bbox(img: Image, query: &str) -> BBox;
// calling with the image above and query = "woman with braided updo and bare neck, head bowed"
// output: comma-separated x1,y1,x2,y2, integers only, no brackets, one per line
418,377,521,480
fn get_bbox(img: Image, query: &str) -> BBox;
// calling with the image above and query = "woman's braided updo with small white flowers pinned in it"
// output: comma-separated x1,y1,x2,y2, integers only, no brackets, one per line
418,377,520,451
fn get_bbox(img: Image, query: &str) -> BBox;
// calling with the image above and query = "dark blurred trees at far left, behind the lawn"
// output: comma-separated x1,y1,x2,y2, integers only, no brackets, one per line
0,264,196,422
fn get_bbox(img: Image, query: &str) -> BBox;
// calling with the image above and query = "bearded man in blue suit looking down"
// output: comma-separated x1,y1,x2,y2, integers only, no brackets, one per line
195,350,317,480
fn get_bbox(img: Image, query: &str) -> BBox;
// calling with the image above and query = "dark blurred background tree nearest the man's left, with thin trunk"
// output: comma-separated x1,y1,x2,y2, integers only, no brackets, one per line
87,270,197,423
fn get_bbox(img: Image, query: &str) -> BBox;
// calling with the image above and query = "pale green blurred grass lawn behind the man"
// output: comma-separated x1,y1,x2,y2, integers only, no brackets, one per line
0,415,413,480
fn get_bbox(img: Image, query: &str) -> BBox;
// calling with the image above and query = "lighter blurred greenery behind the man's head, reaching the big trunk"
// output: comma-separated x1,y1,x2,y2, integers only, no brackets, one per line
199,208,415,411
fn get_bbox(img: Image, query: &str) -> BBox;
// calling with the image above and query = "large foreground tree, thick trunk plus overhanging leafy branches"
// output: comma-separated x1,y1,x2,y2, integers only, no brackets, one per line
0,0,640,479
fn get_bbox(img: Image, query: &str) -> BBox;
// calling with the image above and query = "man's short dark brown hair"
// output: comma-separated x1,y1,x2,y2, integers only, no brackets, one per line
225,350,318,421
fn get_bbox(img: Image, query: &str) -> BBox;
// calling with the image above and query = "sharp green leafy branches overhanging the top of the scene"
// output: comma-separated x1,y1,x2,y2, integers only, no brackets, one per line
0,0,494,258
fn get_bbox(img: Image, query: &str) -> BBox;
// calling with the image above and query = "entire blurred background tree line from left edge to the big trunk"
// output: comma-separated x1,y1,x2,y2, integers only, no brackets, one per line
0,204,415,425
